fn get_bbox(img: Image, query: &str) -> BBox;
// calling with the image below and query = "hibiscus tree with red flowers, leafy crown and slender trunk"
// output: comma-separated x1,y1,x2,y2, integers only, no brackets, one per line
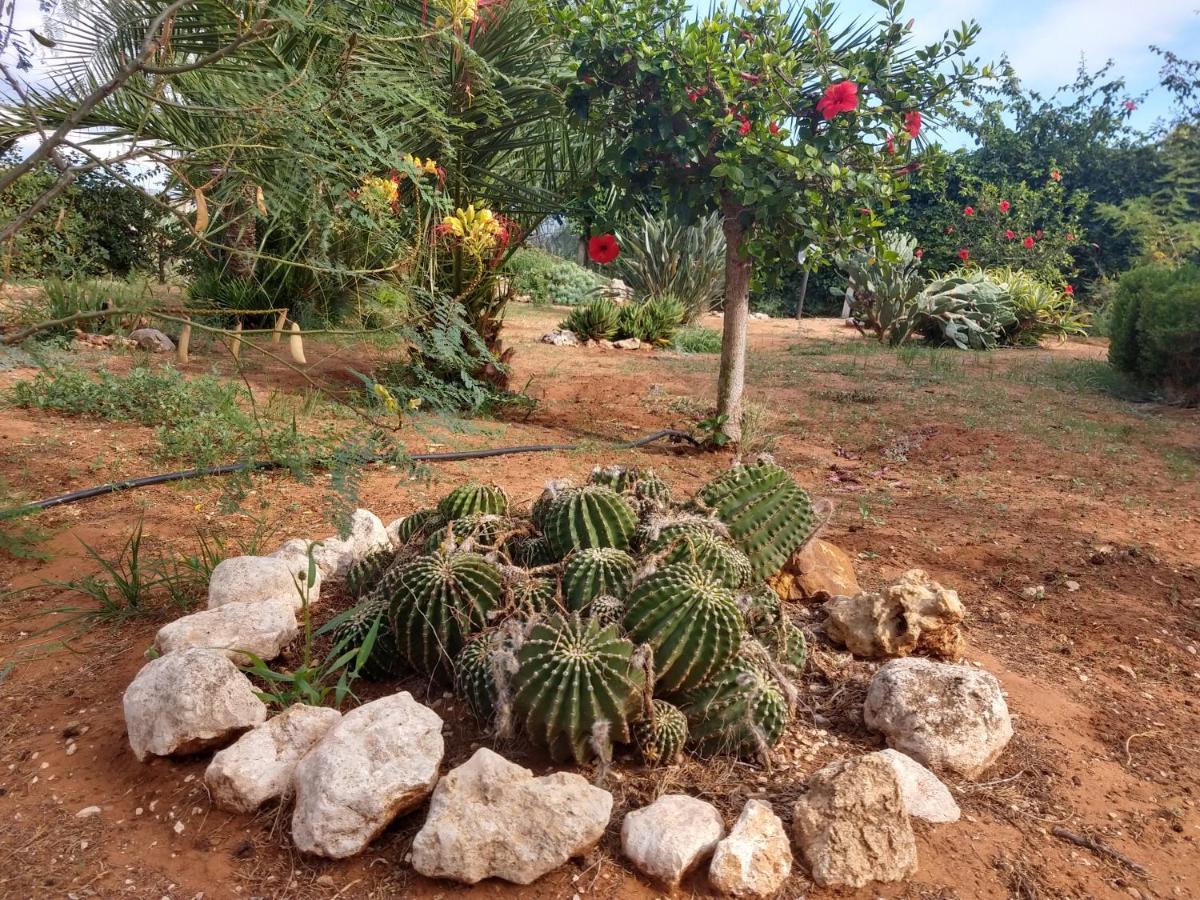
554,0,986,440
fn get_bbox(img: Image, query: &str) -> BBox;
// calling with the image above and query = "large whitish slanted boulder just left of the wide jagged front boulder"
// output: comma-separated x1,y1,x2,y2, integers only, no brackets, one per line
292,691,445,859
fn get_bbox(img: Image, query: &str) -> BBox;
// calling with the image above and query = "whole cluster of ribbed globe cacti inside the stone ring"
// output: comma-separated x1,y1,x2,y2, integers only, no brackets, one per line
340,463,814,766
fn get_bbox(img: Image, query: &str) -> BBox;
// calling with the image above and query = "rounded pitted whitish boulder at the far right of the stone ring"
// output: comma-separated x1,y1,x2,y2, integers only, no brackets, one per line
863,656,1013,778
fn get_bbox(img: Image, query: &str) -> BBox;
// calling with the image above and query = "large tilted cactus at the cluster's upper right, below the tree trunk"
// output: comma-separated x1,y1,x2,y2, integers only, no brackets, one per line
697,462,816,578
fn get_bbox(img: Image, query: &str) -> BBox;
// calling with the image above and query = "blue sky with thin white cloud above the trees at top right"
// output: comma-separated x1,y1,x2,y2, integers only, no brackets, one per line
839,0,1200,143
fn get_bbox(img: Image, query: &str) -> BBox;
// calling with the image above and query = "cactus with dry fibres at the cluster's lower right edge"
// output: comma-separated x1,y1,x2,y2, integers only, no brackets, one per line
679,653,791,757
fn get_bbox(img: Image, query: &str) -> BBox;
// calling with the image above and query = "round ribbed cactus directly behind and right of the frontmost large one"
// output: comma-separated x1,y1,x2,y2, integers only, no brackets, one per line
625,563,743,694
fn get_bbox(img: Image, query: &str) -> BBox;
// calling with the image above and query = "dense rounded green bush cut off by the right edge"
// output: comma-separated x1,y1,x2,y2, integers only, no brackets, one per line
1109,264,1200,404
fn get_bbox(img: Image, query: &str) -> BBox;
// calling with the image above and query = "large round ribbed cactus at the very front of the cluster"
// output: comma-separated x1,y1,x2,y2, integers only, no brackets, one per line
512,613,646,762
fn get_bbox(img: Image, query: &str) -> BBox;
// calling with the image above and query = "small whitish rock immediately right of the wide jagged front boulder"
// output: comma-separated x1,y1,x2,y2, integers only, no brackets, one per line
620,793,725,889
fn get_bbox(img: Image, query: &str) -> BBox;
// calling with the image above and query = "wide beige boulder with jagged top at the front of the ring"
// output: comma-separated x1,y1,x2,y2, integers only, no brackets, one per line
413,748,612,884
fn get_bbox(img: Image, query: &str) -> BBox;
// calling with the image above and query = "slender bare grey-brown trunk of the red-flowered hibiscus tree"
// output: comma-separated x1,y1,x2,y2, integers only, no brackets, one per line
716,194,750,451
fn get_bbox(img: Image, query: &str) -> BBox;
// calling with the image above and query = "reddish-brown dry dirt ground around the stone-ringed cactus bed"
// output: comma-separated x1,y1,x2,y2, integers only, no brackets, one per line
0,307,1200,899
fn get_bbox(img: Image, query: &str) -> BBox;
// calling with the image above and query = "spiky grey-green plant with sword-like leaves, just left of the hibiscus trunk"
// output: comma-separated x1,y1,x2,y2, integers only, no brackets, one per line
613,212,725,323
